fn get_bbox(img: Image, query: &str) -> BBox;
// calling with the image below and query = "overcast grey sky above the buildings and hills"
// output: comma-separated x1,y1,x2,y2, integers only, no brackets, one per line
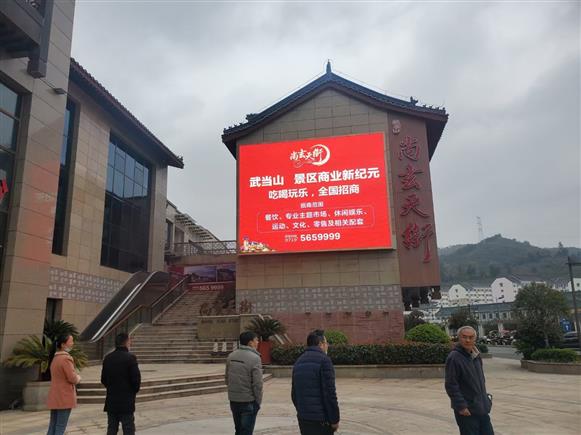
73,0,581,247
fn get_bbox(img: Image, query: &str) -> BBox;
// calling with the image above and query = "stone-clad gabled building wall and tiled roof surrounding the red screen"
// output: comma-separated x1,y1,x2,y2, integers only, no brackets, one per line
223,70,447,342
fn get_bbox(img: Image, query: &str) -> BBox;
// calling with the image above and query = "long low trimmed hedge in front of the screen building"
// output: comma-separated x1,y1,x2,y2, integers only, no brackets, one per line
272,343,451,365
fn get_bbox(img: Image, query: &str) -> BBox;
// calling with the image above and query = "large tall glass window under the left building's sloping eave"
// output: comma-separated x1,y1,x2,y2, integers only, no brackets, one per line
101,137,150,272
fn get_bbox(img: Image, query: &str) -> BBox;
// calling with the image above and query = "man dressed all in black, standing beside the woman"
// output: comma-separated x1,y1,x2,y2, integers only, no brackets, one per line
101,333,141,435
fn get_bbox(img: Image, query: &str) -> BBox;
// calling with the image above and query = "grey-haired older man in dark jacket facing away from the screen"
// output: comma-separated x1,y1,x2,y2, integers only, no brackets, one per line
445,326,494,435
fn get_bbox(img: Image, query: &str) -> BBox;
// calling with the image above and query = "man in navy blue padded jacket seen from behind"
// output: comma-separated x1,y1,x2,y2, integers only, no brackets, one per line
291,330,339,435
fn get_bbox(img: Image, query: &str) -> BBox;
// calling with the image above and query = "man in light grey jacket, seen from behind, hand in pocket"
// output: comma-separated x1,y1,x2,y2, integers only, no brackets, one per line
226,331,262,435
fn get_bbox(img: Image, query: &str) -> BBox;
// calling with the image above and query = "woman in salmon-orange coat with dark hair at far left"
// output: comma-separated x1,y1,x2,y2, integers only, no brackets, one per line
47,335,81,435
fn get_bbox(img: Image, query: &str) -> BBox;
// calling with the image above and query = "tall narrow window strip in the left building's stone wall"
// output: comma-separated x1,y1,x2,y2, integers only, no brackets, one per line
52,100,75,255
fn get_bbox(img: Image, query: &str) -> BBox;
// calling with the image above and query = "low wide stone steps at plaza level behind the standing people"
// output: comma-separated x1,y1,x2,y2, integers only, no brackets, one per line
77,374,272,404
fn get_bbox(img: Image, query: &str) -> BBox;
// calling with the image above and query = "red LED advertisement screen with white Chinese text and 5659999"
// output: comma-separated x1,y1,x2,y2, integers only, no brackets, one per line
238,133,392,254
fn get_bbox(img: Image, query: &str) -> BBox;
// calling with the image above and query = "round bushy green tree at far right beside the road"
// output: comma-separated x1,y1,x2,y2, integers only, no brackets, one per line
513,283,569,358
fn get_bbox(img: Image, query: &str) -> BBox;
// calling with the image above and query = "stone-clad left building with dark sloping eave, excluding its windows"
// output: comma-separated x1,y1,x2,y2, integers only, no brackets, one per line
0,0,183,408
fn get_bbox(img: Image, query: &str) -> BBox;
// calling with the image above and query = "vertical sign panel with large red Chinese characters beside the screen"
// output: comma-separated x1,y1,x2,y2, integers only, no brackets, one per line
390,118,440,287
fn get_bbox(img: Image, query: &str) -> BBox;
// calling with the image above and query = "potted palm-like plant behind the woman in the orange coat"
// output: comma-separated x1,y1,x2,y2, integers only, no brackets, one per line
4,320,88,411
